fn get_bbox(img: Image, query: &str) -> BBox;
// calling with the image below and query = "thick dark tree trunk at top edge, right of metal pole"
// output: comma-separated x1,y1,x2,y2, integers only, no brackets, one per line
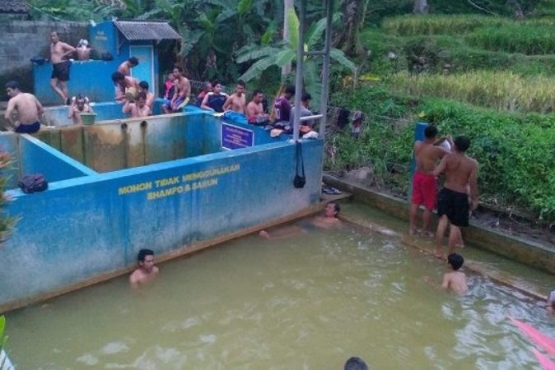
333,0,370,56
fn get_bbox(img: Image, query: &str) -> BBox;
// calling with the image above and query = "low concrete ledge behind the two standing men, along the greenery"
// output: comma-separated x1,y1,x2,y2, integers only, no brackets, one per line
323,175,555,273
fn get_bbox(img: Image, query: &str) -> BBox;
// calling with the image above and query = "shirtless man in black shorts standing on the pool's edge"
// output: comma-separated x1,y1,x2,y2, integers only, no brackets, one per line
433,136,478,258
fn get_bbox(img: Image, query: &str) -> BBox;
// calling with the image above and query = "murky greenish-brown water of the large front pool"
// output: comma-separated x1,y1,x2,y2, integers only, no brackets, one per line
3,223,555,370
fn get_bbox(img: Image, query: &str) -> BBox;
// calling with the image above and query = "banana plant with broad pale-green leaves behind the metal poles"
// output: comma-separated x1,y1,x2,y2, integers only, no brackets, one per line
235,9,356,106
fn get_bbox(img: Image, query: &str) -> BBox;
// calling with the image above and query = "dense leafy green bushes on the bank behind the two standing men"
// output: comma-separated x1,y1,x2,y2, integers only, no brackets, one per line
332,86,555,221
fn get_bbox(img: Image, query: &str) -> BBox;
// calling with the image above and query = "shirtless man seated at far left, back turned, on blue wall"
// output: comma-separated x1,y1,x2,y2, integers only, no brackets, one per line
4,81,44,134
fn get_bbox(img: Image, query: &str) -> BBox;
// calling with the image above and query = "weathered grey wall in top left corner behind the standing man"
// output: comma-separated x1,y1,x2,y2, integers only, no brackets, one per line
0,20,88,100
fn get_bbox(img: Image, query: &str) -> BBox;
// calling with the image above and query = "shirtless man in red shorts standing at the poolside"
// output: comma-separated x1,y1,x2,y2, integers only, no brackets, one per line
409,126,452,236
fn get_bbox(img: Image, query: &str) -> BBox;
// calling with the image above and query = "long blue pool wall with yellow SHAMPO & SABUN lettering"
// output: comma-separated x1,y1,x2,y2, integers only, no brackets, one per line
0,113,323,305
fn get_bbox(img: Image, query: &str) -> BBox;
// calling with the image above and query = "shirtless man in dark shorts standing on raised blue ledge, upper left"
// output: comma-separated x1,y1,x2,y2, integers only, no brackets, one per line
50,31,75,105
